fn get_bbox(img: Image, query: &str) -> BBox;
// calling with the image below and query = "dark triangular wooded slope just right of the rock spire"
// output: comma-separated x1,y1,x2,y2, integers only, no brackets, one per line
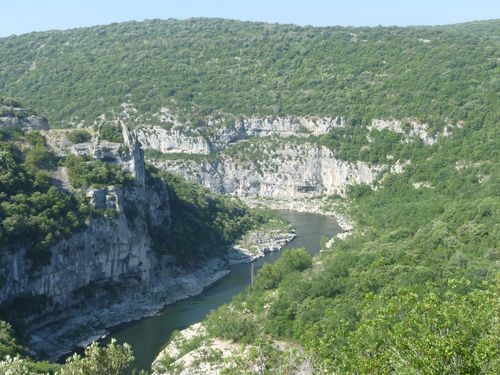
148,167,269,263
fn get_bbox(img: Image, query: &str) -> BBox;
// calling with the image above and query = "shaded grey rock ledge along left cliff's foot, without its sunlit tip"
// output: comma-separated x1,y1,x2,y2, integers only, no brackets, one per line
36,258,230,361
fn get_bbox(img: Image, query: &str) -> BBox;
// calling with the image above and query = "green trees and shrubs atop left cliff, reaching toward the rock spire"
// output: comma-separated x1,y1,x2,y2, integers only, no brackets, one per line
0,120,137,265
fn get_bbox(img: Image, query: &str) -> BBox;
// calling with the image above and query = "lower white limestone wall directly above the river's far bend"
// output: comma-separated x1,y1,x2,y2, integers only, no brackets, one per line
156,143,385,200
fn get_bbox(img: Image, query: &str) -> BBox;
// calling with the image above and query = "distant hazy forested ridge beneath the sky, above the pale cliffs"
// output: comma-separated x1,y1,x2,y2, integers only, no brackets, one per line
0,19,500,127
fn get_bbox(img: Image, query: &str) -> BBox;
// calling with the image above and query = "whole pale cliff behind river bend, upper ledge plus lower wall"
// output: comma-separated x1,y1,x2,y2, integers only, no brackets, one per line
135,117,386,199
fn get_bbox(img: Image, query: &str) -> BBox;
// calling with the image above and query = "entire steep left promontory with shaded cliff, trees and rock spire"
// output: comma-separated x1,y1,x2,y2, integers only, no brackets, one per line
0,105,293,360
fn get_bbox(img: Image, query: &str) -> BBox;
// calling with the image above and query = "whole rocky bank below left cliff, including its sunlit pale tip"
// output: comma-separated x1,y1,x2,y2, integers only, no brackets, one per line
42,219,295,361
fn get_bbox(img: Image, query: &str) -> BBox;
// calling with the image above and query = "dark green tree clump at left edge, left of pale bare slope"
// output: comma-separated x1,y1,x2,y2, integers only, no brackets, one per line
0,129,88,263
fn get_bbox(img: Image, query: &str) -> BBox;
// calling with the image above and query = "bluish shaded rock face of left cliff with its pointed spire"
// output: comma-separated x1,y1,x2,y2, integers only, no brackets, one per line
0,127,170,306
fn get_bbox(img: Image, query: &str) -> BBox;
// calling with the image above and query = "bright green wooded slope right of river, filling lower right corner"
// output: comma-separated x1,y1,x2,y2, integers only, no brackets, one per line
201,117,500,374
